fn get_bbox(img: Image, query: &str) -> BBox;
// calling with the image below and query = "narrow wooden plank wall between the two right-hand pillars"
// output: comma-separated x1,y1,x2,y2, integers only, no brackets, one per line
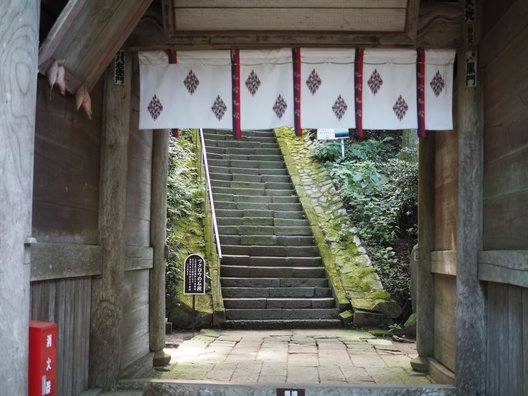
429,132,458,372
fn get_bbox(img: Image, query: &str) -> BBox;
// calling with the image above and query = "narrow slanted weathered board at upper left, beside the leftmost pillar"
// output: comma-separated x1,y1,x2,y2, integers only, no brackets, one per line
39,0,88,73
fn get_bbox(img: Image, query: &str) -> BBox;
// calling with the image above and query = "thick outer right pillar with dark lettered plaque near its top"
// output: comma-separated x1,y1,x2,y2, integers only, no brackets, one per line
455,1,486,395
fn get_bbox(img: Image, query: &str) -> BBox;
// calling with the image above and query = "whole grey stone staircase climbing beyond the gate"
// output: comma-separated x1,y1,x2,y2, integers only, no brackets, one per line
204,130,340,328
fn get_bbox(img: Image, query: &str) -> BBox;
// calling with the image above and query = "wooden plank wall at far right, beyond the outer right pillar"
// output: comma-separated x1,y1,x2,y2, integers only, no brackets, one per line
479,0,528,395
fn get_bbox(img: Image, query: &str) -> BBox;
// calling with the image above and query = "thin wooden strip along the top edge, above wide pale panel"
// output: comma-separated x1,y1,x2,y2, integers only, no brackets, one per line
172,0,407,8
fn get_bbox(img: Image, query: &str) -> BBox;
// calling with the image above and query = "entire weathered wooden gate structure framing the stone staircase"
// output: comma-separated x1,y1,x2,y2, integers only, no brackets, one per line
0,0,528,395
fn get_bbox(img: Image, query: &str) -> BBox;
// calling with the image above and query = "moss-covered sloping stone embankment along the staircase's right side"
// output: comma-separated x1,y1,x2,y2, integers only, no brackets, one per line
275,128,396,324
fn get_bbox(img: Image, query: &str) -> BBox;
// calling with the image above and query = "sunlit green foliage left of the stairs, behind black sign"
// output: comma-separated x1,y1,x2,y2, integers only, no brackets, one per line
166,130,205,305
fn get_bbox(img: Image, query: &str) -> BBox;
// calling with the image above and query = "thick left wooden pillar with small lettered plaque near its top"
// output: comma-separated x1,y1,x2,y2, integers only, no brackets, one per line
90,53,131,390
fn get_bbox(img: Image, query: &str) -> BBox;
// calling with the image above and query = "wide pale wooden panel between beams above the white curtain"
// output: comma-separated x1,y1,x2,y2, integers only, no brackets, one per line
171,8,406,32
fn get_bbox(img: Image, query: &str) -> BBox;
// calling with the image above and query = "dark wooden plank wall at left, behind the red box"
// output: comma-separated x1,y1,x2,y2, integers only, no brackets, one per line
31,77,102,395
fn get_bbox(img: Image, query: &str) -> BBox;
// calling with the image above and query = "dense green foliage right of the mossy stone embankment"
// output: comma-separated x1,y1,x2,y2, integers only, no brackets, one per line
310,133,418,313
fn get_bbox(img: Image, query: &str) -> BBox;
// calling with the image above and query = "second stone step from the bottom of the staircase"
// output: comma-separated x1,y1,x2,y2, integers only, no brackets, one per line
226,308,338,320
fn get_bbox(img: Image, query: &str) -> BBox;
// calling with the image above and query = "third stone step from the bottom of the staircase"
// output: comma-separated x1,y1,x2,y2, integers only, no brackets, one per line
224,297,335,309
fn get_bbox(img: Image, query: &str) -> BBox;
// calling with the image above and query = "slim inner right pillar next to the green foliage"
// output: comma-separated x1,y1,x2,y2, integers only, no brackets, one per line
412,134,435,371
